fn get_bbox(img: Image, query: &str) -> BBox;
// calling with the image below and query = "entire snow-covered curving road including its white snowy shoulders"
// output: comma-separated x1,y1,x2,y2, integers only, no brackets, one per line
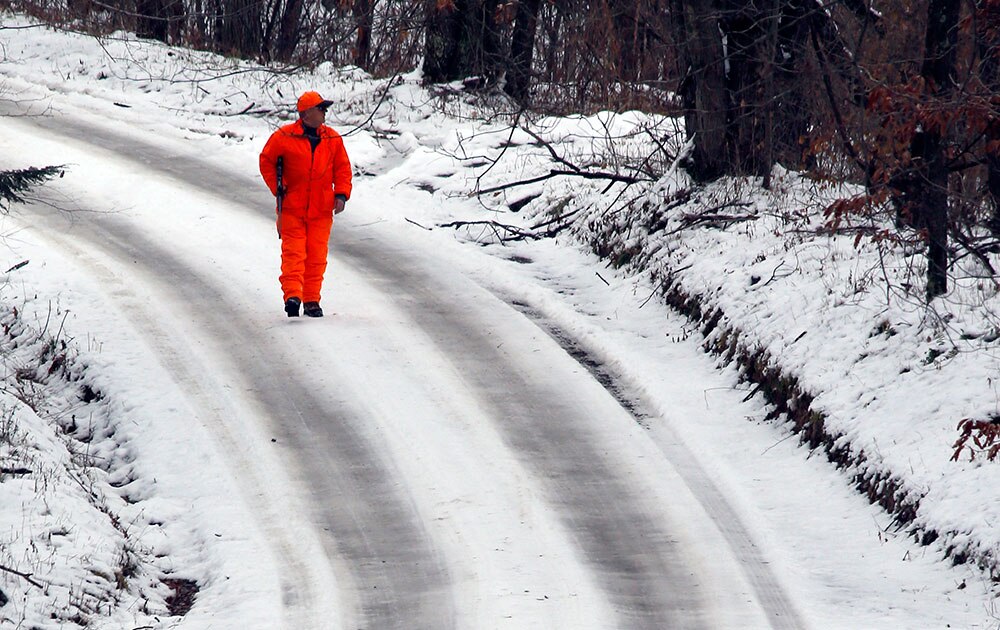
0,40,996,630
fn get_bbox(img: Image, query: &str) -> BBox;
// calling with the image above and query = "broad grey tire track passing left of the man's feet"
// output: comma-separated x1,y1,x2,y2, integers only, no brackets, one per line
22,206,454,628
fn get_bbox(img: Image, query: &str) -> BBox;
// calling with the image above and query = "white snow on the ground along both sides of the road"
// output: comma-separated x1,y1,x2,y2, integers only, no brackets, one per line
0,16,1000,628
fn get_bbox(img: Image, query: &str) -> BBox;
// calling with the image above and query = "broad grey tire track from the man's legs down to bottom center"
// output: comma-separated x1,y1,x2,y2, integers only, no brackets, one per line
337,235,748,630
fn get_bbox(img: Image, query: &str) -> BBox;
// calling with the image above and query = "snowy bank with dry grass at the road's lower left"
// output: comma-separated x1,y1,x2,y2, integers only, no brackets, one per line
0,302,185,625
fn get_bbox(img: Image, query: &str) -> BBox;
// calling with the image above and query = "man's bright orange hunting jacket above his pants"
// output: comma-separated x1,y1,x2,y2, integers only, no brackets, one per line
260,121,351,217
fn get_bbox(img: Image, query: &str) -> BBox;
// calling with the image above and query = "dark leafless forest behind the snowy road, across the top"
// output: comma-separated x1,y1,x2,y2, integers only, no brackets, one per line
7,0,1000,300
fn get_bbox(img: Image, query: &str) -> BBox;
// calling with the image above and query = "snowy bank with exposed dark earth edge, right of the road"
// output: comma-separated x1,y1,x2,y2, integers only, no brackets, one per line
556,148,1000,580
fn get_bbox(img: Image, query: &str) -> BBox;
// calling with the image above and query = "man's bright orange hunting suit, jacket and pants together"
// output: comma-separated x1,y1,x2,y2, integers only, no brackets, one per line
260,120,351,302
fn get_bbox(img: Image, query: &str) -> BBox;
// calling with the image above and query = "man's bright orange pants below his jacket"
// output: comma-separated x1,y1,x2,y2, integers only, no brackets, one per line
278,213,333,302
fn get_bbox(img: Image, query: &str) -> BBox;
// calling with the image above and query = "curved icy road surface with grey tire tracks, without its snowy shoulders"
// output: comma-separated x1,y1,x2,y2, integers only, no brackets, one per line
5,111,804,629
